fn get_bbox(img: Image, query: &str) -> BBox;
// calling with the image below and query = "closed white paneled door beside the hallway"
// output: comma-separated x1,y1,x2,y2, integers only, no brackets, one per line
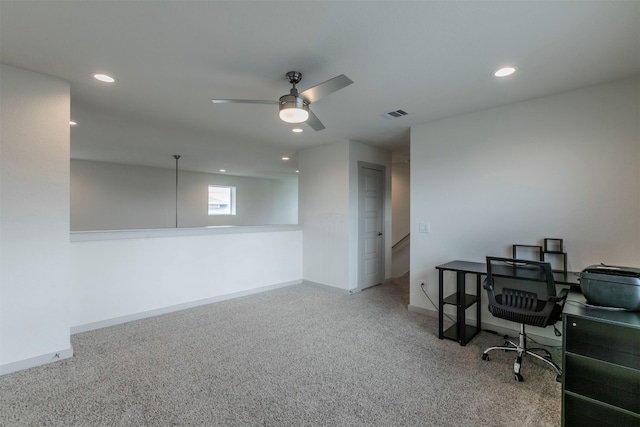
358,166,384,288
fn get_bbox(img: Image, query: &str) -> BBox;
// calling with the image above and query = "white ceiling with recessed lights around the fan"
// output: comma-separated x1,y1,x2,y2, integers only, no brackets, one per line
0,0,640,176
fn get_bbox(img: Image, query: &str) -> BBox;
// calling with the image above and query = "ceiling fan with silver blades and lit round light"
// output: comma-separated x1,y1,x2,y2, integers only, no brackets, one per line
211,71,353,131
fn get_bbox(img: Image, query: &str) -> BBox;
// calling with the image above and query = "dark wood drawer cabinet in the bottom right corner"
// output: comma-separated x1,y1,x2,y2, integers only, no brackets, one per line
562,305,640,427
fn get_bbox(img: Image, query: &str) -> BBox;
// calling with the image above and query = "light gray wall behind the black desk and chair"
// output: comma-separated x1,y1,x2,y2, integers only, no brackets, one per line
411,78,640,338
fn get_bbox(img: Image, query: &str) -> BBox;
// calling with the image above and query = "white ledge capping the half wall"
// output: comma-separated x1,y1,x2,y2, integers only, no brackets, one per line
70,225,302,242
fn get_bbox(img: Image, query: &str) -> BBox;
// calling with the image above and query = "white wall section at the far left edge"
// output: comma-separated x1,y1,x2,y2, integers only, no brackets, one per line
0,64,72,374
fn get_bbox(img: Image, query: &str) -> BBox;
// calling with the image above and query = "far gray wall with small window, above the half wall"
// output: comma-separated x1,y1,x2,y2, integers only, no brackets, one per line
71,160,298,231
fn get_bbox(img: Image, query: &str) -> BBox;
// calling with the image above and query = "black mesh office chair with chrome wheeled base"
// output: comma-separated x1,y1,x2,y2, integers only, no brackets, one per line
482,257,568,381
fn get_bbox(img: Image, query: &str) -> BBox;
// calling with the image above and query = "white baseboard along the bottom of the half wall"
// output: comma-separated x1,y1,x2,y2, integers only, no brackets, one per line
71,280,302,335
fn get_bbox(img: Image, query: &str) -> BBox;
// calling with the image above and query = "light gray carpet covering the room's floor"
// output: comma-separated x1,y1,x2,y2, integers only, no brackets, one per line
0,278,560,426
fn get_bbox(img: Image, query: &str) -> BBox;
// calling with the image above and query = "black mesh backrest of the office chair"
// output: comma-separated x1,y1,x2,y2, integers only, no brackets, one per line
485,257,556,326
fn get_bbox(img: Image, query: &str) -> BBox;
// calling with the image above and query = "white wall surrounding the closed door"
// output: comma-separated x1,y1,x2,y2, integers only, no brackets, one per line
299,141,391,290
